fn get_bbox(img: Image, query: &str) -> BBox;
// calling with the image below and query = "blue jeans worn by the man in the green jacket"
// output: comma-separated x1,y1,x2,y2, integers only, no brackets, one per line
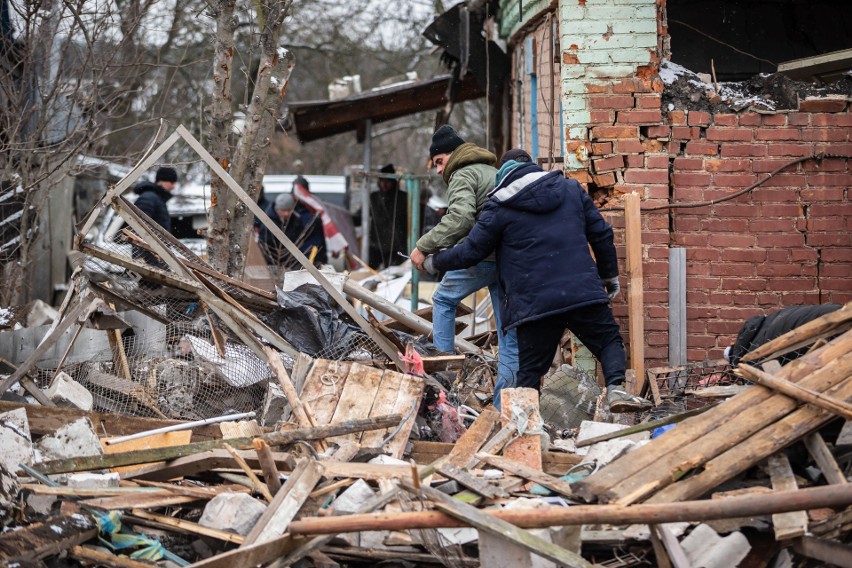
432,261,518,409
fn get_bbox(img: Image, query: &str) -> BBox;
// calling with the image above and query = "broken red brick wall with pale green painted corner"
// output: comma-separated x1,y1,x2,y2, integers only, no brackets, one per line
502,0,852,366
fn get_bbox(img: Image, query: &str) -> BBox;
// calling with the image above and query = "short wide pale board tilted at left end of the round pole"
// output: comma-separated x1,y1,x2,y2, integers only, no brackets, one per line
242,459,323,547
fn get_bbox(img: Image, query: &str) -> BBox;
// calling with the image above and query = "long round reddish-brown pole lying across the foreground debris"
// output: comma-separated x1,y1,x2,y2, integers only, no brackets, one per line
288,484,852,535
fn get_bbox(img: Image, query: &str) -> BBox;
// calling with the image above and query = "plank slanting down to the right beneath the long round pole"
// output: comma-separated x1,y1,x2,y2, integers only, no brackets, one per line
401,481,592,568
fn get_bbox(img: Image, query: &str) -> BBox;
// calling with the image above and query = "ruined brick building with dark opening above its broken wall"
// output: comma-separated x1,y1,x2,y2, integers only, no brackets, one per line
492,0,852,366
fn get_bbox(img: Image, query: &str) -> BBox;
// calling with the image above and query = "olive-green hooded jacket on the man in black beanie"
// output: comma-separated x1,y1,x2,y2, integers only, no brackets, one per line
417,142,497,260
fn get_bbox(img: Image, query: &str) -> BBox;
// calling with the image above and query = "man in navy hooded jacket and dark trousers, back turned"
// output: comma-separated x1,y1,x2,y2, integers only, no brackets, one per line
425,149,650,412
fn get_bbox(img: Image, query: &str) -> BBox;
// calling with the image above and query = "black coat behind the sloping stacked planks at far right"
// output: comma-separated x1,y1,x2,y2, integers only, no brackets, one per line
730,304,842,366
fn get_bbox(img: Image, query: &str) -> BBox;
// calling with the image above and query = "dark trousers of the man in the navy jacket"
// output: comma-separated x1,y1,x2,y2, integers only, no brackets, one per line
515,304,626,390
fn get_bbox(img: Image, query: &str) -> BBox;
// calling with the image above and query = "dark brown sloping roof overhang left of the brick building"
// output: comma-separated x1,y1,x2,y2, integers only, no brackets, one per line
289,74,485,143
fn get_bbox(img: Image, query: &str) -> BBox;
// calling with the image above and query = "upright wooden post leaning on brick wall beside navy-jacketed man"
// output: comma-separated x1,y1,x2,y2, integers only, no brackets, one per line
624,193,645,394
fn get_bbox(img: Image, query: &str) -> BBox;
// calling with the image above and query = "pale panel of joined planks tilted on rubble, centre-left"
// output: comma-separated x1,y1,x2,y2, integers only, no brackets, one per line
301,359,424,458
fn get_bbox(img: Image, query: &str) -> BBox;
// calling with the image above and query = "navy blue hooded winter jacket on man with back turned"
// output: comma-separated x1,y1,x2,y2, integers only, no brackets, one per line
433,164,618,329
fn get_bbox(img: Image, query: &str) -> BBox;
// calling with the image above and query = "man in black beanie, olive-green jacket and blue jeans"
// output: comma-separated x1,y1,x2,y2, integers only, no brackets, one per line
410,124,518,408
